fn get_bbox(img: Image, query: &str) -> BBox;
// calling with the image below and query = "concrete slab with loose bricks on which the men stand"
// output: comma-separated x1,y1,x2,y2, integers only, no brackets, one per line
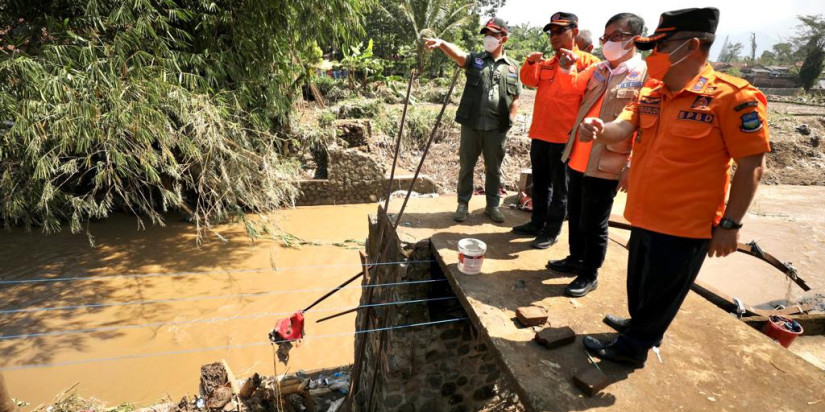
390,196,825,411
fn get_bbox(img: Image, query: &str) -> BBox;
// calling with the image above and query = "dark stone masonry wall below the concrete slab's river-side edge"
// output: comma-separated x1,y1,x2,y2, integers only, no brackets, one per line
352,211,516,412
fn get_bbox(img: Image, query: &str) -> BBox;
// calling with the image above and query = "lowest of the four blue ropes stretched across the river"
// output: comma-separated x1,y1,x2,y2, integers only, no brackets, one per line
0,318,467,372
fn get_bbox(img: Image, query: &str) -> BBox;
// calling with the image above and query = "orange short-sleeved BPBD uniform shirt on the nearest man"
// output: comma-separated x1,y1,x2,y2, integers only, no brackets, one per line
619,64,770,239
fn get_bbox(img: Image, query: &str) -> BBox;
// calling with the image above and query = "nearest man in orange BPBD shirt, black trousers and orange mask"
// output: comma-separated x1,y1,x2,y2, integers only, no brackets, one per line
579,8,770,367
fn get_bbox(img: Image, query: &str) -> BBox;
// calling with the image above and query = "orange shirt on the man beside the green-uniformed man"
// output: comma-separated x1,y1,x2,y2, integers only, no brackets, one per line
519,46,599,143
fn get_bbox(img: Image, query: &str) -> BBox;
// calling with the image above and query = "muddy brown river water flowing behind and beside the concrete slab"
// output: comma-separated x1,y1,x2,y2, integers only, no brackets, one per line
0,186,825,406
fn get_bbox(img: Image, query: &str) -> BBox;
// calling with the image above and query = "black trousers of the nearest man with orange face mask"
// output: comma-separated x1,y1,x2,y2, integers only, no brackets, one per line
619,228,710,350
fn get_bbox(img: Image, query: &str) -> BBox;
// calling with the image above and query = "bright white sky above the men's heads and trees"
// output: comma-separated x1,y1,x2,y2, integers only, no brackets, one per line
492,0,825,60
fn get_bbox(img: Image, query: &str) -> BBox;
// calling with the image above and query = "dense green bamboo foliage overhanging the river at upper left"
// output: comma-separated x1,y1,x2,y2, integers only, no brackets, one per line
0,0,367,241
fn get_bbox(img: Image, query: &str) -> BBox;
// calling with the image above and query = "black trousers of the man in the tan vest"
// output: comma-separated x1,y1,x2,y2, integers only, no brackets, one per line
567,166,619,280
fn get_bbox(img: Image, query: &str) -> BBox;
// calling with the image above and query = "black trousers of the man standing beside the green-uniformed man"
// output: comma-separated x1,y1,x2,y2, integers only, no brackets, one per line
530,139,567,236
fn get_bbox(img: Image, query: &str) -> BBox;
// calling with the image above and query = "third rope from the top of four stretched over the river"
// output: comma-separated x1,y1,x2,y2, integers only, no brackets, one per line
0,297,456,341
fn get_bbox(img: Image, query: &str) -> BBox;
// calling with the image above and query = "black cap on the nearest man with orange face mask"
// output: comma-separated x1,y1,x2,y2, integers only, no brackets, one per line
636,7,719,50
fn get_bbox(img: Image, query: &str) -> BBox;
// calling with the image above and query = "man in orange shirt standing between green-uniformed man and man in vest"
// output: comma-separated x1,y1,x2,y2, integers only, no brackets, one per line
513,12,599,249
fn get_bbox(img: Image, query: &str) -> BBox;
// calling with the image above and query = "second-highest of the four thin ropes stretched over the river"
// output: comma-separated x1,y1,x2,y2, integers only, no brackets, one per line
0,279,447,315
